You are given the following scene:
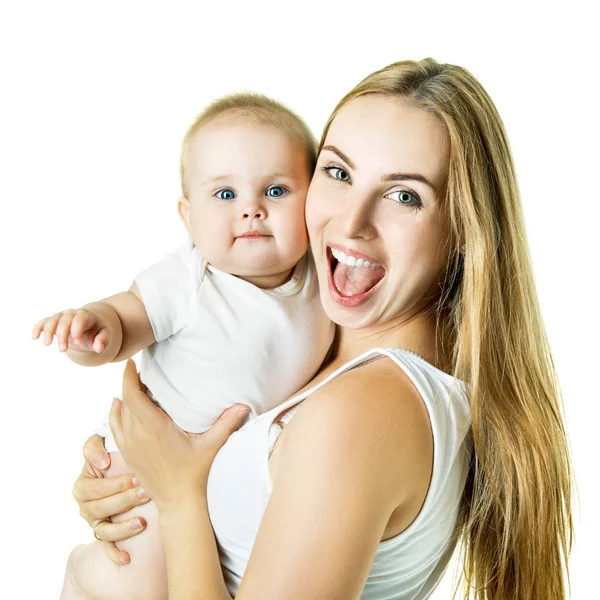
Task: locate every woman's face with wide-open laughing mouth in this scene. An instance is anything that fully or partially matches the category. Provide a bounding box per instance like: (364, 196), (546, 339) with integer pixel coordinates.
(306, 94), (449, 329)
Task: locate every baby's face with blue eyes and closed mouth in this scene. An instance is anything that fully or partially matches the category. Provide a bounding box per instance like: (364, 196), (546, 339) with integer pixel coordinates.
(180, 117), (312, 287)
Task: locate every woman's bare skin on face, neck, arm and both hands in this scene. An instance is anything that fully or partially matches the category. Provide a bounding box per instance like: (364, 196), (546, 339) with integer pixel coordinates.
(74, 96), (449, 600)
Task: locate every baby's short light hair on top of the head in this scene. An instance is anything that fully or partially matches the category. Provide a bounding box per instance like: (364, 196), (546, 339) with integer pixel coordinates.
(179, 92), (318, 197)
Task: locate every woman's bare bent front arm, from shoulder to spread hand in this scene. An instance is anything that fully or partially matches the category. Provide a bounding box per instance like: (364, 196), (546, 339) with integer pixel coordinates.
(111, 359), (433, 600)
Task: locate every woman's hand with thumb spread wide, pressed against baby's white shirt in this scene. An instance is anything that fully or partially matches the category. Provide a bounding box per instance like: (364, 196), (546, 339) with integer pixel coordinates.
(110, 360), (250, 510)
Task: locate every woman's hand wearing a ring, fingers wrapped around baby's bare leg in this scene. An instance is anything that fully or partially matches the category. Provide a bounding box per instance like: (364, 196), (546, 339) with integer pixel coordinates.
(73, 435), (149, 565)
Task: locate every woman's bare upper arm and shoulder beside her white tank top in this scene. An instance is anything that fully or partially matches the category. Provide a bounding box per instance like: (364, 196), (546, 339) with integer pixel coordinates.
(236, 359), (433, 600)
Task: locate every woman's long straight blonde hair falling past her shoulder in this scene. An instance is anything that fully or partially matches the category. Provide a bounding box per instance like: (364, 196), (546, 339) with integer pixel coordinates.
(319, 58), (573, 600)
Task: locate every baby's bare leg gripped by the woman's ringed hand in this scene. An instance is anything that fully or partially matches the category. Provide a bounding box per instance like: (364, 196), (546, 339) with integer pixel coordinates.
(61, 452), (167, 600)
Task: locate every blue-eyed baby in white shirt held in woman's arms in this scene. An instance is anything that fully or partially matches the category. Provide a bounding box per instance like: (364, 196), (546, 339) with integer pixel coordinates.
(33, 94), (334, 600)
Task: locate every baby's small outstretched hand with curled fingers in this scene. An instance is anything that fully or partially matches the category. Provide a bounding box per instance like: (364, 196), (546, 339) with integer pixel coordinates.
(32, 308), (109, 354)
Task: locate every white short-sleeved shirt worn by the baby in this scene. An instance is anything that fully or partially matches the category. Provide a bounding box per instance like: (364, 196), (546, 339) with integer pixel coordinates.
(96, 241), (335, 452)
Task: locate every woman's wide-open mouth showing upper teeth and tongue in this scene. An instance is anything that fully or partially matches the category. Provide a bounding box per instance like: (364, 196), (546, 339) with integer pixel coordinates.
(326, 246), (386, 308)
